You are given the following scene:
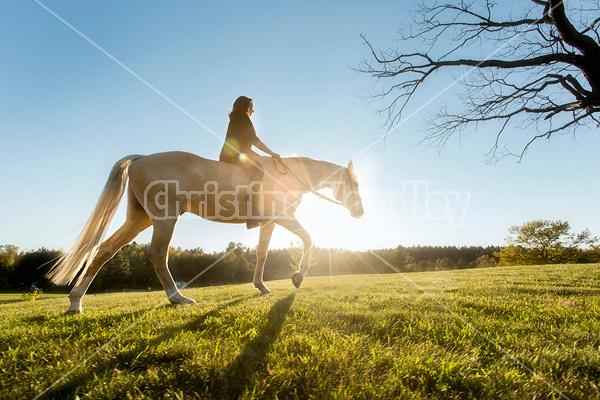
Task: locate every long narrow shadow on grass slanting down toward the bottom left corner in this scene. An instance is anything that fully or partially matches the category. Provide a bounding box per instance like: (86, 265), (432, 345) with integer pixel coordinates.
(43, 296), (255, 399)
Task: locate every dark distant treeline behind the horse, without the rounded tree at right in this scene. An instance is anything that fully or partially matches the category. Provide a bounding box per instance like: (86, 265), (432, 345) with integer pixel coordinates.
(0, 242), (501, 291)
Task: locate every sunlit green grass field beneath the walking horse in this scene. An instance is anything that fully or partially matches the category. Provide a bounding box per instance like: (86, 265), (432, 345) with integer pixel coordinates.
(0, 264), (600, 399)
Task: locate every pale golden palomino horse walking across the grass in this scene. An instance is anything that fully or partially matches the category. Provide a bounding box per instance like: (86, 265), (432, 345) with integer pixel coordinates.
(48, 152), (363, 314)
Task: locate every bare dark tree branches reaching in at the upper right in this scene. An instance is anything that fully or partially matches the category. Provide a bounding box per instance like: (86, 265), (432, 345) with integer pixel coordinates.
(357, 0), (600, 161)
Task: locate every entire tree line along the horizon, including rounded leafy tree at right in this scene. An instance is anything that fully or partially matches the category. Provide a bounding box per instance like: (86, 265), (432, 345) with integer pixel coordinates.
(0, 220), (600, 292)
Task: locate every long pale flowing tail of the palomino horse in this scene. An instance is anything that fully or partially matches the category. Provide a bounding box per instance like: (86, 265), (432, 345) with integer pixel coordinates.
(47, 155), (143, 285)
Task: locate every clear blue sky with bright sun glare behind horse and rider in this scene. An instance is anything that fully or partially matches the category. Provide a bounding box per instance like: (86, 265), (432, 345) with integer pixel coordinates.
(0, 0), (600, 251)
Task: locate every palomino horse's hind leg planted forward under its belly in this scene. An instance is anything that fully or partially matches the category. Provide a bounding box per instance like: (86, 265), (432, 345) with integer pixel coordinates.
(148, 218), (196, 304)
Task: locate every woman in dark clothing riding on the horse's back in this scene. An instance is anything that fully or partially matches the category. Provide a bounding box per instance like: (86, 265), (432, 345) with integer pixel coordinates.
(219, 96), (281, 229)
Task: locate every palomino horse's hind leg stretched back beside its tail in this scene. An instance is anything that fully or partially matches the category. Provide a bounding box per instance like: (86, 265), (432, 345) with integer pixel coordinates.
(65, 198), (152, 314)
